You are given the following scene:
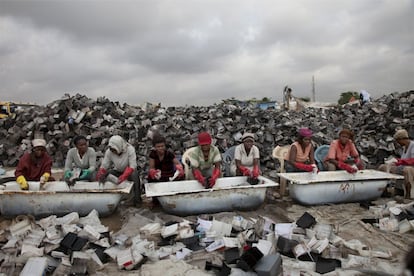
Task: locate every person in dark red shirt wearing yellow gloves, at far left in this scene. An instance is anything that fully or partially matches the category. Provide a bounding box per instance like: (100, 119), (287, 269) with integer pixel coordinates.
(14, 139), (54, 190)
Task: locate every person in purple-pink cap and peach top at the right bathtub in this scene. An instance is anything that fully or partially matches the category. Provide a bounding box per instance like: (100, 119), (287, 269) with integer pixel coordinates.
(286, 128), (317, 172)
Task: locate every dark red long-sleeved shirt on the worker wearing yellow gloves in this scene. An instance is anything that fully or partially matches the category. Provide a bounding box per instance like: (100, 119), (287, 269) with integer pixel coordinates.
(14, 152), (52, 181)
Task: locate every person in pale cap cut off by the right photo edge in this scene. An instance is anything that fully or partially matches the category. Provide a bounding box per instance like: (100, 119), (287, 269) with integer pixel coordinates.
(378, 129), (414, 198)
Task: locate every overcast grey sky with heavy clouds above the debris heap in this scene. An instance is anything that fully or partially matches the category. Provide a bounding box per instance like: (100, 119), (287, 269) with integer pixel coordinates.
(0, 0), (414, 106)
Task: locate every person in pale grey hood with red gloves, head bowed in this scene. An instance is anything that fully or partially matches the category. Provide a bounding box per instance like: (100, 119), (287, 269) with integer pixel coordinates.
(96, 135), (141, 204)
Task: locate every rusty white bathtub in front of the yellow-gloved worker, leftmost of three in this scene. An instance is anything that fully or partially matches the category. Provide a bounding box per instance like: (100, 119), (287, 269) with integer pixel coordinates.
(0, 181), (133, 217)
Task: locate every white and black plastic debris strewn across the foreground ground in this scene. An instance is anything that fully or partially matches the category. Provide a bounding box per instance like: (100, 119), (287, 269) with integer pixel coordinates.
(0, 198), (414, 276)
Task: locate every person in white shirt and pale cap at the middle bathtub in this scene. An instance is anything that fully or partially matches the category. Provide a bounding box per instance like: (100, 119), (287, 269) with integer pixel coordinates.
(234, 132), (260, 179)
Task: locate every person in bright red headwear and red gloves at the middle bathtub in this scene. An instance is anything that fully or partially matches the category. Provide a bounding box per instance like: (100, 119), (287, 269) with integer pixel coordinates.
(184, 132), (221, 188)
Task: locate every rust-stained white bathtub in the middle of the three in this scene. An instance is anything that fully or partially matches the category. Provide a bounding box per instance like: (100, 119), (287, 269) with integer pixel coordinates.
(145, 176), (279, 216)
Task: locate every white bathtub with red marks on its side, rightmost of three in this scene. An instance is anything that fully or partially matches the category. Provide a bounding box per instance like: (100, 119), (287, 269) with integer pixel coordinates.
(278, 170), (404, 205)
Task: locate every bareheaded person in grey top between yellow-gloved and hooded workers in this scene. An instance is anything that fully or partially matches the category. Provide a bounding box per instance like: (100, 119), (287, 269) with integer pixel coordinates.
(64, 135), (96, 182)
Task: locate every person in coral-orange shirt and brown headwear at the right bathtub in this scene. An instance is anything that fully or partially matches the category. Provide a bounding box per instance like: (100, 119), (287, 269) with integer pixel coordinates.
(324, 128), (364, 173)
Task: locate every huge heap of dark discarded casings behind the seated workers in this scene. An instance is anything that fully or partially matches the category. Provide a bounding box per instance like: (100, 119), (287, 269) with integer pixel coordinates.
(0, 91), (414, 178)
